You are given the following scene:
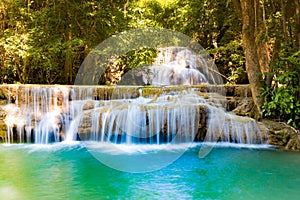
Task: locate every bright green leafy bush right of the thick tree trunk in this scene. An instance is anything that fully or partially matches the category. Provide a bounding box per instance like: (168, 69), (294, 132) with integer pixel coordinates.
(261, 48), (300, 129)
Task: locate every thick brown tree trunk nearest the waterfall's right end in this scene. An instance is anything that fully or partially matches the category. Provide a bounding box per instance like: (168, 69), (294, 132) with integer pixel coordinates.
(240, 0), (264, 119)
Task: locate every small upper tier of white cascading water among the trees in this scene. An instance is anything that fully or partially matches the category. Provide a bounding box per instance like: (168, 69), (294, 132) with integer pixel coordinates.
(137, 47), (219, 85)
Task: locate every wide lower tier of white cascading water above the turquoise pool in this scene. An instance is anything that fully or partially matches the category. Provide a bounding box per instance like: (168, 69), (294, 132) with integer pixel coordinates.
(0, 86), (264, 144)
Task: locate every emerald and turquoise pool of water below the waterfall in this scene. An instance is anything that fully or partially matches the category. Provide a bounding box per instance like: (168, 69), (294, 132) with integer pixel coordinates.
(0, 144), (300, 199)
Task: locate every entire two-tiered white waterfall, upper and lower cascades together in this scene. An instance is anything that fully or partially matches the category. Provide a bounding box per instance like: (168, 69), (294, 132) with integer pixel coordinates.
(0, 47), (265, 144)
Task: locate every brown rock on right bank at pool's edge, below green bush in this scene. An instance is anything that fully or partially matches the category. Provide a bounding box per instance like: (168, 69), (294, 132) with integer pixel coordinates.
(259, 119), (300, 151)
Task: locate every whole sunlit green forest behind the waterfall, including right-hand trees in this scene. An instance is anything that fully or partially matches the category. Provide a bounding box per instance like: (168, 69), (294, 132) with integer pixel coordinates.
(0, 0), (300, 128)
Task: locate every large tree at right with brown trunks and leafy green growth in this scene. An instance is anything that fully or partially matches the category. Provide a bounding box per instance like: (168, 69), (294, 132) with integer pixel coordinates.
(232, 0), (300, 128)
